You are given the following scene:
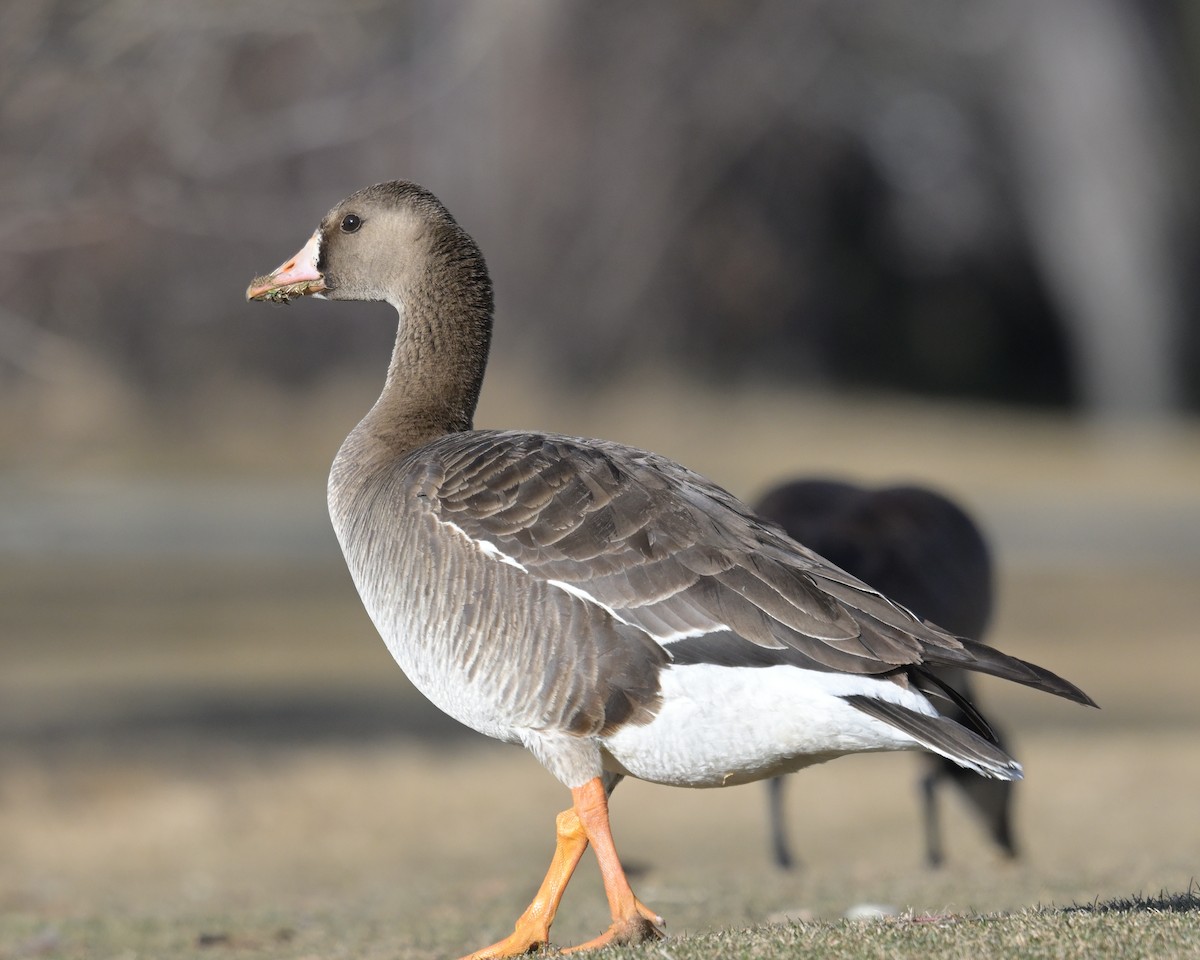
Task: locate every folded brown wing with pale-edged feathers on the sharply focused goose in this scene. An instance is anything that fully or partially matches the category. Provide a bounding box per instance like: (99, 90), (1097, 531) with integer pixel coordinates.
(416, 431), (970, 673)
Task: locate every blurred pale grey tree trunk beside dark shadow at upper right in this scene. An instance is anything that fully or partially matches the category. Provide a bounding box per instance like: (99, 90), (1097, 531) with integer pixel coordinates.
(1002, 0), (1186, 416)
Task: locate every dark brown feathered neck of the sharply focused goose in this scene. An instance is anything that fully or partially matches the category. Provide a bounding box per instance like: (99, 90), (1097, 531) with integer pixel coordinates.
(359, 221), (493, 455)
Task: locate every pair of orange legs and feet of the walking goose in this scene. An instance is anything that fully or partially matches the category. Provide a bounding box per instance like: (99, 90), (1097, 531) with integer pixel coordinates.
(462, 778), (662, 960)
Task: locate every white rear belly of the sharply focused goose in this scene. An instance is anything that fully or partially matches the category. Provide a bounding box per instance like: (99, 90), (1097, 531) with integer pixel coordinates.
(604, 664), (935, 787)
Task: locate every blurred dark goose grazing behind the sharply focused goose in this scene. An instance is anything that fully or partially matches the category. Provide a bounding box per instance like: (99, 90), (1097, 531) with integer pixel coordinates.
(755, 478), (1016, 868)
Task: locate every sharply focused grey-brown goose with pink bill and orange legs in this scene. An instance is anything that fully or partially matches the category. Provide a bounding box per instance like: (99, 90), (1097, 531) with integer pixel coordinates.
(246, 181), (1091, 956)
